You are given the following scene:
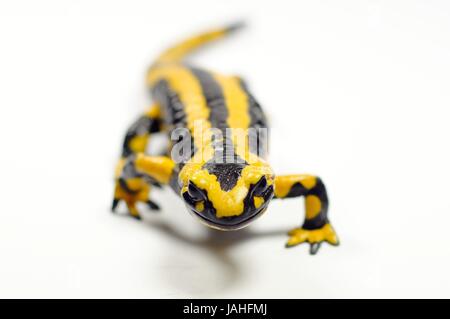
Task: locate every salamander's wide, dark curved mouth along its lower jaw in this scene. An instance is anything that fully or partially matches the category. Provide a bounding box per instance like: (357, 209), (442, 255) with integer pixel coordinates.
(188, 203), (268, 231)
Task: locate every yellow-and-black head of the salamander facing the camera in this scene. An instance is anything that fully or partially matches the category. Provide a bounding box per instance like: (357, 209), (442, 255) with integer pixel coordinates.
(180, 162), (274, 230)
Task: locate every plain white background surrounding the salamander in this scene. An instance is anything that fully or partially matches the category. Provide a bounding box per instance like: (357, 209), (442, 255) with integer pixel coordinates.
(0, 0), (450, 298)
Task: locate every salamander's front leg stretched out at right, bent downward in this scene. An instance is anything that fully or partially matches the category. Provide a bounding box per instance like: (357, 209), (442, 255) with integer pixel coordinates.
(275, 175), (339, 255)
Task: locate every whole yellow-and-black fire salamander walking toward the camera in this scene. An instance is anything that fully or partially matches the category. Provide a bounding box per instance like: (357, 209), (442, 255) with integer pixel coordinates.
(112, 25), (338, 254)
